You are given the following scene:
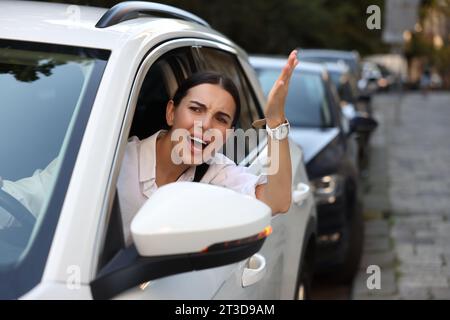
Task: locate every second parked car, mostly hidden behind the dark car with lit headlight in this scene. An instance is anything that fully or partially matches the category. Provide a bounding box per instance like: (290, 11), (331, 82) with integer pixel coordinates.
(325, 63), (378, 175)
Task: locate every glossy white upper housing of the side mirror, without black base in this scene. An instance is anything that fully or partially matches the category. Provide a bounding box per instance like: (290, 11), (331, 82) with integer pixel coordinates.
(131, 182), (272, 257)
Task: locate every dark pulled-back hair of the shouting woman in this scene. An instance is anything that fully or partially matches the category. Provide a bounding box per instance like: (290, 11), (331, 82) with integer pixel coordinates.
(172, 71), (241, 127)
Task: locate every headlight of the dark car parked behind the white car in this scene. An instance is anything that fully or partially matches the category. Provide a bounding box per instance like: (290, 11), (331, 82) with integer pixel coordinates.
(310, 174), (344, 204)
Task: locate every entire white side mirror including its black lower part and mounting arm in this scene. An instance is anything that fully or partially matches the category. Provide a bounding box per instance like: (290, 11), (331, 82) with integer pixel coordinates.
(91, 182), (272, 299)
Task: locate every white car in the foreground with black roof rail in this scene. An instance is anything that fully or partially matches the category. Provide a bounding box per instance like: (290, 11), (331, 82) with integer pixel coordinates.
(0, 1), (316, 299)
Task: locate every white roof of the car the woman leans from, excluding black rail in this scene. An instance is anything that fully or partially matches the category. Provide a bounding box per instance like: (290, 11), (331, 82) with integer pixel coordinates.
(0, 0), (243, 53)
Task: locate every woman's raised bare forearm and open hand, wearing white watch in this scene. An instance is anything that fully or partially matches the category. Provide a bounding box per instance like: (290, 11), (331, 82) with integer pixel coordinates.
(255, 50), (298, 214)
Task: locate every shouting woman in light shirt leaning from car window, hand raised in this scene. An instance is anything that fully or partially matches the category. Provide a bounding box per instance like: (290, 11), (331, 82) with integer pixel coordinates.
(0, 50), (298, 242)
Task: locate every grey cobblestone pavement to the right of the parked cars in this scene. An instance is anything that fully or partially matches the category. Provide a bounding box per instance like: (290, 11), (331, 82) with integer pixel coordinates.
(351, 93), (450, 299)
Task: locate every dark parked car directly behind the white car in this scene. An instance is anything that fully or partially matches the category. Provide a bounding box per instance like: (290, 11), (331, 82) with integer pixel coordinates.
(250, 56), (372, 282)
